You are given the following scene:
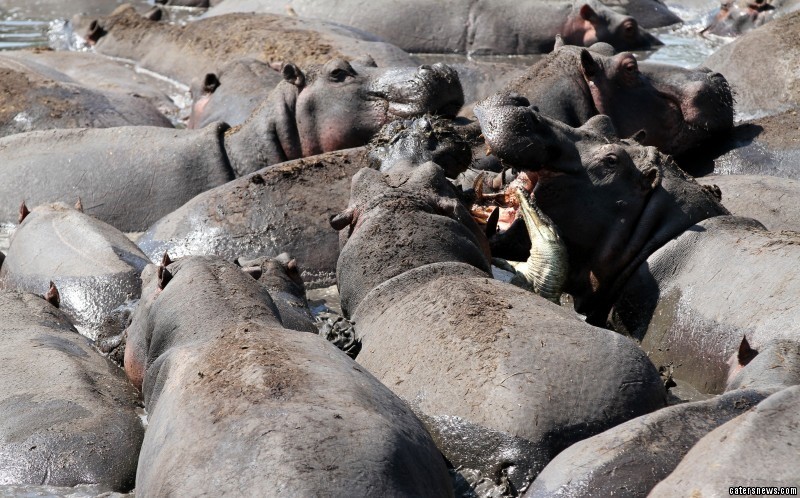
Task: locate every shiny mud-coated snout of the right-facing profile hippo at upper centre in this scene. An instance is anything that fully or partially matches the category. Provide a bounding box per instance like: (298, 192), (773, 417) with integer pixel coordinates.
(367, 63), (464, 118)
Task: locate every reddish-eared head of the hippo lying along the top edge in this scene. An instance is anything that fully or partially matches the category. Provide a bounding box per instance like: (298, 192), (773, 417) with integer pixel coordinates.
(561, 3), (662, 50)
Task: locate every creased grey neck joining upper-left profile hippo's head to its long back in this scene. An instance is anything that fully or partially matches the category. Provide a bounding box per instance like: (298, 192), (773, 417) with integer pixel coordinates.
(225, 82), (302, 177)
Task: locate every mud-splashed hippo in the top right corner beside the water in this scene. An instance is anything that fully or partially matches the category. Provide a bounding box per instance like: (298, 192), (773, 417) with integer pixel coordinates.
(703, 0), (800, 36)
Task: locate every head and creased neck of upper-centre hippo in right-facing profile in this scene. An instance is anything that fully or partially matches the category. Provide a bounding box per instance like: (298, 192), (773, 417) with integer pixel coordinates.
(226, 59), (464, 171)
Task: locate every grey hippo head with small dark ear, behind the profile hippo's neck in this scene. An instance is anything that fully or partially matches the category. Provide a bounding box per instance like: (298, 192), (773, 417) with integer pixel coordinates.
(187, 59), (283, 128)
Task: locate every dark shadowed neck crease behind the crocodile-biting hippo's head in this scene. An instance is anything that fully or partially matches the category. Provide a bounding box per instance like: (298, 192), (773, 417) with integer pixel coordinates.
(576, 160), (730, 326)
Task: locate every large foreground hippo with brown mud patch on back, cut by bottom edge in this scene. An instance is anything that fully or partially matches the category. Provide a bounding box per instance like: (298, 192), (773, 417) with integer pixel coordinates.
(125, 257), (453, 496)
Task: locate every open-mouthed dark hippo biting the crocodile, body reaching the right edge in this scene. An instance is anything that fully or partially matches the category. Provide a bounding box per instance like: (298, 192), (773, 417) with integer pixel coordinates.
(476, 95), (800, 394)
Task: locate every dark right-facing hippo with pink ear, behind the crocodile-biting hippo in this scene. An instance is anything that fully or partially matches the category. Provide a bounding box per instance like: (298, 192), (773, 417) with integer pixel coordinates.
(505, 44), (733, 155)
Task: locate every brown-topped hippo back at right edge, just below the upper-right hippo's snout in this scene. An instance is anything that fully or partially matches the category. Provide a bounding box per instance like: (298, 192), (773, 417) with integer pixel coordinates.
(681, 110), (800, 180)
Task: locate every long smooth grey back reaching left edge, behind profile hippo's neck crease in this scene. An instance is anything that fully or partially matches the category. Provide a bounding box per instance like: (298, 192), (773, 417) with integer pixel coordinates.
(0, 124), (234, 232)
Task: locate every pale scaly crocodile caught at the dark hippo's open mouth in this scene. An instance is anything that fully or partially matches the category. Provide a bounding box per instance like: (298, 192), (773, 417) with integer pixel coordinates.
(500, 189), (569, 304)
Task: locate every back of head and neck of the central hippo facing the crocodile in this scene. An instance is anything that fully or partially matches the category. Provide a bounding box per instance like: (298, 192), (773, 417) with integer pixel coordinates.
(331, 162), (490, 314)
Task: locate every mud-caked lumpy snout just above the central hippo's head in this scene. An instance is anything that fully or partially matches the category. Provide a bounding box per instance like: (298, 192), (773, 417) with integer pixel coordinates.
(367, 115), (472, 178)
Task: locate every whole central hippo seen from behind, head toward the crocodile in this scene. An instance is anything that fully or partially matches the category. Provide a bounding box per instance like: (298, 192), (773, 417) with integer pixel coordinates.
(331, 163), (664, 492)
